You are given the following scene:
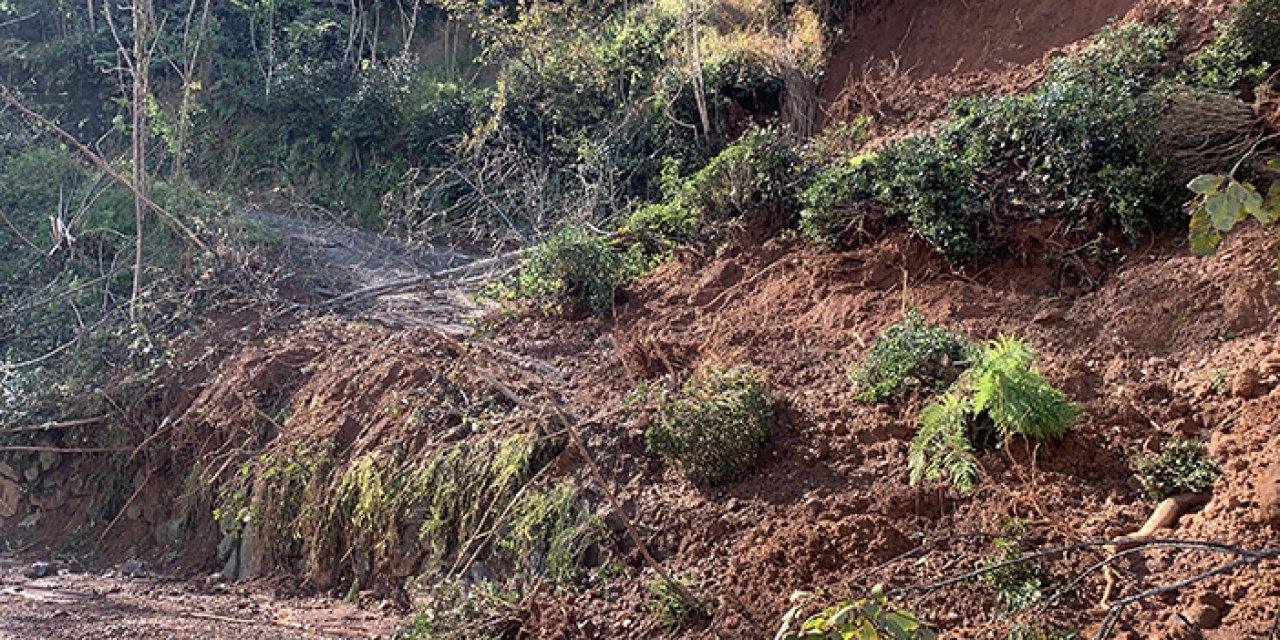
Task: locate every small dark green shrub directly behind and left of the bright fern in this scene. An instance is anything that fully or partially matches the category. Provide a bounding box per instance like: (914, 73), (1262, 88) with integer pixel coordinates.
(850, 308), (973, 402)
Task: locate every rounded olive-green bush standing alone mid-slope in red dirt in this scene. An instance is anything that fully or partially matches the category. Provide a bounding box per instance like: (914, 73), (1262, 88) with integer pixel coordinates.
(644, 366), (773, 485)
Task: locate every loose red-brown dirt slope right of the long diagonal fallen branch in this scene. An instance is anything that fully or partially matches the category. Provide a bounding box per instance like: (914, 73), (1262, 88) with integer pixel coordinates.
(488, 224), (1280, 639)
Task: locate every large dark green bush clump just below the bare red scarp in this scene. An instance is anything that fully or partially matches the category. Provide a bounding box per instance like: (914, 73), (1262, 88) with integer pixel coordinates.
(876, 23), (1175, 262)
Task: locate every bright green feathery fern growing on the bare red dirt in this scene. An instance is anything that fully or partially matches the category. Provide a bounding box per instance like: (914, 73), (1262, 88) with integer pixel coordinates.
(908, 337), (1079, 493)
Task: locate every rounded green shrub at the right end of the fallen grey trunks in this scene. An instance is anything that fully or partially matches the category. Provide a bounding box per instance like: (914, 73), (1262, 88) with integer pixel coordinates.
(509, 227), (637, 317)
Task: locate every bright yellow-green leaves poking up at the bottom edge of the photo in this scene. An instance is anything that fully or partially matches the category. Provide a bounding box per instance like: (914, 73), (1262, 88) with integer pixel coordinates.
(774, 586), (934, 640)
